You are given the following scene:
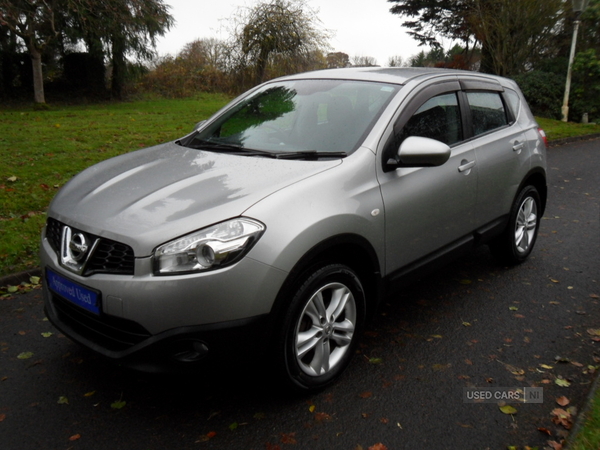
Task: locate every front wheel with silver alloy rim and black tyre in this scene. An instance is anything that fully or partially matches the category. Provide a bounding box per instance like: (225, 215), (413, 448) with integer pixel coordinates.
(277, 264), (365, 391)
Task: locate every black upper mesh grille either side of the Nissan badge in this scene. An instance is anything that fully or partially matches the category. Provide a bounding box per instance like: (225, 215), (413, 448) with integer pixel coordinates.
(46, 218), (135, 276)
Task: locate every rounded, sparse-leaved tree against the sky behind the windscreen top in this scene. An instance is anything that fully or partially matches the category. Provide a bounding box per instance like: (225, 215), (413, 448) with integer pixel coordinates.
(233, 0), (329, 83)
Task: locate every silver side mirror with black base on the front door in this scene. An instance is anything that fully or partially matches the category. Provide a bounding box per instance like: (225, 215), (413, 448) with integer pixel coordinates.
(387, 136), (451, 168)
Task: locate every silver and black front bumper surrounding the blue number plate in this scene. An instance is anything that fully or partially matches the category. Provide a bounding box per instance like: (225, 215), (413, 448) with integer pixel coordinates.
(41, 234), (285, 372)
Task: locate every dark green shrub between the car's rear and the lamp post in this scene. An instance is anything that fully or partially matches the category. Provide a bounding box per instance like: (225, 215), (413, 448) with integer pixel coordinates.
(514, 70), (566, 119)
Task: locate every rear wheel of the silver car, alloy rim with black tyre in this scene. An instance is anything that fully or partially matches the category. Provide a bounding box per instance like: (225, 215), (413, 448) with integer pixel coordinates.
(490, 186), (542, 264)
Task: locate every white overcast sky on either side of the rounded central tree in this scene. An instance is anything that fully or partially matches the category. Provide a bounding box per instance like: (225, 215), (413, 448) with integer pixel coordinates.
(157, 0), (423, 66)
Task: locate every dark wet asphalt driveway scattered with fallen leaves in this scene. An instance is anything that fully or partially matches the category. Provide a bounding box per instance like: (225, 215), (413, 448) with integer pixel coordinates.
(0, 140), (600, 450)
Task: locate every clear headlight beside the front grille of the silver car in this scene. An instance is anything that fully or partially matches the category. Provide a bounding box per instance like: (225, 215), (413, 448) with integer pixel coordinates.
(154, 218), (265, 275)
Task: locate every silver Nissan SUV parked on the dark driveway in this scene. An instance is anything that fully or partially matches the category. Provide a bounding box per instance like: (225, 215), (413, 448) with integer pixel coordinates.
(41, 68), (547, 390)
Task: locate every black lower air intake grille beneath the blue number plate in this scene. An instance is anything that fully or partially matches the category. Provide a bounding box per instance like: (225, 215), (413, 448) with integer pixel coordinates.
(52, 293), (151, 351)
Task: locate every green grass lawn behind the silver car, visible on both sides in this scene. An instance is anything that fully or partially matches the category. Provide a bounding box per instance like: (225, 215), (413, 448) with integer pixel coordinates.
(0, 99), (600, 276)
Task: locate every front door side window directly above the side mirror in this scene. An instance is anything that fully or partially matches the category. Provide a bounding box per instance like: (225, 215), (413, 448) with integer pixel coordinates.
(400, 93), (462, 145)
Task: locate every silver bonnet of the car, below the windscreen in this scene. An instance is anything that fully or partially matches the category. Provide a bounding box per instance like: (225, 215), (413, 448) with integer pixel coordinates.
(48, 143), (341, 257)
